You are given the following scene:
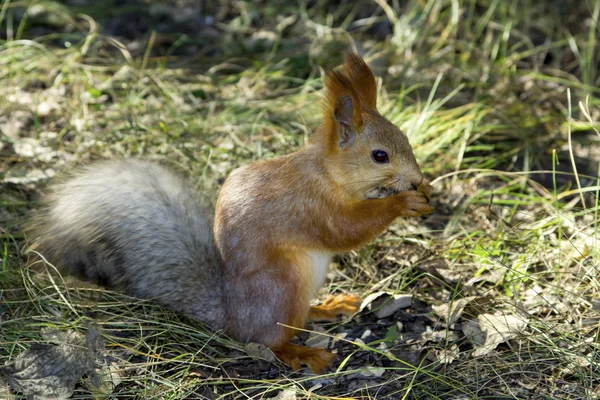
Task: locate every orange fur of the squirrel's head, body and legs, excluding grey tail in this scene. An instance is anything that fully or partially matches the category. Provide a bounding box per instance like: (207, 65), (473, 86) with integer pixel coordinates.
(214, 54), (432, 371)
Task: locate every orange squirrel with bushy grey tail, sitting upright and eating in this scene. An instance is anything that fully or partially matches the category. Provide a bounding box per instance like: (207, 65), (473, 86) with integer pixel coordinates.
(31, 53), (433, 372)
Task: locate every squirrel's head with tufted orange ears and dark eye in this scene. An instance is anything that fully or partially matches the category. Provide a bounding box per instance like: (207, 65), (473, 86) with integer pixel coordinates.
(319, 53), (423, 199)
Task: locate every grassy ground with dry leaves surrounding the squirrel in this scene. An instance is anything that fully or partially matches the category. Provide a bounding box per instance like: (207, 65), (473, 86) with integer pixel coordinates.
(0, 0), (600, 399)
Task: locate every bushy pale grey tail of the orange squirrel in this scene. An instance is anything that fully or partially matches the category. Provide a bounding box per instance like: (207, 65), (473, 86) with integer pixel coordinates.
(33, 160), (224, 328)
